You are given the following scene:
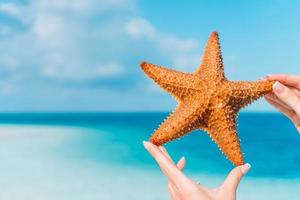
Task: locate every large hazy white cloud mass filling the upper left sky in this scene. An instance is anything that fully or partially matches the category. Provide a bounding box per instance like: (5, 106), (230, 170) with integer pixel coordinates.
(0, 0), (197, 84)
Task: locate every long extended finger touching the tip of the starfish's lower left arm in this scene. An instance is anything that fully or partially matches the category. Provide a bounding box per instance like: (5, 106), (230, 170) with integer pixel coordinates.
(143, 141), (187, 185)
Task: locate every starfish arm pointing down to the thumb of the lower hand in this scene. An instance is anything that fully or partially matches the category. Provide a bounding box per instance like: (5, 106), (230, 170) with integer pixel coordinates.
(206, 108), (244, 165)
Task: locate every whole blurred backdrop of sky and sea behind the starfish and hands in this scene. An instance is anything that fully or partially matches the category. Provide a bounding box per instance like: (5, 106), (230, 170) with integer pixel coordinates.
(0, 0), (300, 200)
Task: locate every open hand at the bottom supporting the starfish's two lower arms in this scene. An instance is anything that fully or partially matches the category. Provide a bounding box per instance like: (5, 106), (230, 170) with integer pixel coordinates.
(143, 142), (250, 200)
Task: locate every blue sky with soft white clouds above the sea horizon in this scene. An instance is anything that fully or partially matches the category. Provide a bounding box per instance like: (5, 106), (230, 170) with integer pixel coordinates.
(0, 0), (300, 112)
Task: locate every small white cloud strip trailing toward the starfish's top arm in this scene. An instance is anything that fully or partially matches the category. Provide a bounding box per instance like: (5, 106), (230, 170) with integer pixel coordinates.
(125, 18), (200, 71)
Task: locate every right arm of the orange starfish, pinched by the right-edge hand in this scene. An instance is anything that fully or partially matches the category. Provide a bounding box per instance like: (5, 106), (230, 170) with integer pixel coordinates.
(229, 81), (274, 111)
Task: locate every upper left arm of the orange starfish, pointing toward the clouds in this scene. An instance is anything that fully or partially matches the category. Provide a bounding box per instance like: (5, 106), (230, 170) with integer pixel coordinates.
(141, 62), (196, 101)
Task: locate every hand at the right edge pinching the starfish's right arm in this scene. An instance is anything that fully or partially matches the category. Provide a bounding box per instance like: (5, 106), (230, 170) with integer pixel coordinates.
(265, 74), (300, 133)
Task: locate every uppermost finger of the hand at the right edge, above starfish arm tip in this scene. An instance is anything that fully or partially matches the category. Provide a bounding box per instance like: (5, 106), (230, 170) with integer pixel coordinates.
(267, 74), (300, 89)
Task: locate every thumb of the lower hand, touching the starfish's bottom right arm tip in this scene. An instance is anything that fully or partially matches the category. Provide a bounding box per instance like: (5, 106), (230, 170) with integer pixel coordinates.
(223, 163), (251, 191)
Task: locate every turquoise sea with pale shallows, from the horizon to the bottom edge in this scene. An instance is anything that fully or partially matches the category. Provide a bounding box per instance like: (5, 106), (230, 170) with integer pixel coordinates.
(0, 113), (300, 200)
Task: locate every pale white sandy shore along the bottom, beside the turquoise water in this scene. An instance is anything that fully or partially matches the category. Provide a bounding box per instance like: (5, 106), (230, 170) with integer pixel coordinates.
(0, 126), (300, 200)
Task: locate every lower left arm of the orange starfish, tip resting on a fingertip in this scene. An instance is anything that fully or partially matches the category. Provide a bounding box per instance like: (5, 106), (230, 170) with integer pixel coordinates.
(150, 103), (206, 145)
